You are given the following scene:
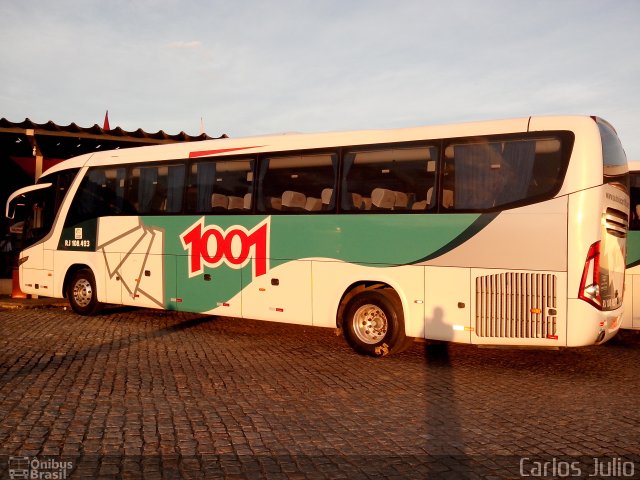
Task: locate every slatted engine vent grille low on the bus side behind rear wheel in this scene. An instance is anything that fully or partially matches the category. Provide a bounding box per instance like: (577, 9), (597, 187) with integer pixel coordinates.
(475, 272), (558, 339)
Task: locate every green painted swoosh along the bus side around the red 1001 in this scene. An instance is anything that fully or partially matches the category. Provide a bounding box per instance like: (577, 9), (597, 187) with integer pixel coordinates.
(142, 213), (497, 311)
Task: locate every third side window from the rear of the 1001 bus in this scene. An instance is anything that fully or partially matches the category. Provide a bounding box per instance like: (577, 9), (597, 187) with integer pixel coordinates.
(256, 153), (338, 213)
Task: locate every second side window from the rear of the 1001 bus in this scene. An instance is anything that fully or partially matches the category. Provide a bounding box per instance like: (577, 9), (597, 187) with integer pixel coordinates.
(340, 147), (438, 212)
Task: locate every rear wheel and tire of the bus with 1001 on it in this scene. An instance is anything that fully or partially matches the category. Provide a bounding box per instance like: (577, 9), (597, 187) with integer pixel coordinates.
(342, 290), (407, 357)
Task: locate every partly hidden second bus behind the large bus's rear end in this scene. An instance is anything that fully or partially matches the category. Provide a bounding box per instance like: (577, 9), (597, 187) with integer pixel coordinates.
(621, 160), (640, 330)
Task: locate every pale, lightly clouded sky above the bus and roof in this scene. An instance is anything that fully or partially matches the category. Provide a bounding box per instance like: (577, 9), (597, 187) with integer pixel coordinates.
(0, 0), (640, 160)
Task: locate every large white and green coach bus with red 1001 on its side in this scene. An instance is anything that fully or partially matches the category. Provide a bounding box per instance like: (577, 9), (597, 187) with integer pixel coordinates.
(6, 116), (629, 356)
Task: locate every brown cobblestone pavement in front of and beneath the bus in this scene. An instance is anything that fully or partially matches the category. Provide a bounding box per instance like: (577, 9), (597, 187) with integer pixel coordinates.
(0, 308), (640, 479)
